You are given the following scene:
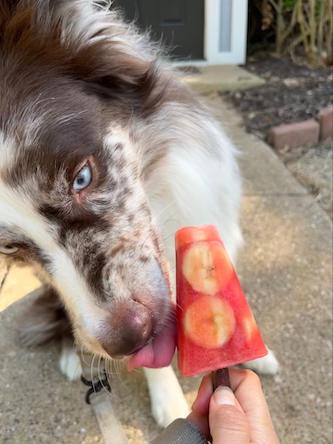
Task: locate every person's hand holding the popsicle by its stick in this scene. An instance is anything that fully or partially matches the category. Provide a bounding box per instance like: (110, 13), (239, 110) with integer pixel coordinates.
(188, 369), (279, 444)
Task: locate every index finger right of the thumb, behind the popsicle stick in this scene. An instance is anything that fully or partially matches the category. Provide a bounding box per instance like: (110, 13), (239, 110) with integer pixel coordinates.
(230, 369), (279, 444)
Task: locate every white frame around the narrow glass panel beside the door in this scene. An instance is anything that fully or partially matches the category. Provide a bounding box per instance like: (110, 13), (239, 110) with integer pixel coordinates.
(204, 0), (248, 65)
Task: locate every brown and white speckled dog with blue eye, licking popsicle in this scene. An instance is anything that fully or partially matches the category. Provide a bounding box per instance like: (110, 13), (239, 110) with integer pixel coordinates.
(0, 0), (278, 425)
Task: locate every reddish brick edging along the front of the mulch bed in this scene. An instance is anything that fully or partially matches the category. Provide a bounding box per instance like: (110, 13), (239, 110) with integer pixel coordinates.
(269, 105), (333, 150)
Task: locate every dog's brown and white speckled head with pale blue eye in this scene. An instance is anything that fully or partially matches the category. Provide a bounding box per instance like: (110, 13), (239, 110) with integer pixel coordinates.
(0, 0), (171, 362)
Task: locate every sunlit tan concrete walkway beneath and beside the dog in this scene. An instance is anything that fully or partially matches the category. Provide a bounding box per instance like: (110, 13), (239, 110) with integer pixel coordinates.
(0, 97), (332, 444)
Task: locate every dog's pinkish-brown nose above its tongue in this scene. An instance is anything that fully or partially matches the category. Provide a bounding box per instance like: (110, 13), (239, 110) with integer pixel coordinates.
(101, 300), (154, 357)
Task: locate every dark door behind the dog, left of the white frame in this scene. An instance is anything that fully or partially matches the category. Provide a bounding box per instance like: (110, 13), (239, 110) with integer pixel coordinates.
(112, 0), (204, 59)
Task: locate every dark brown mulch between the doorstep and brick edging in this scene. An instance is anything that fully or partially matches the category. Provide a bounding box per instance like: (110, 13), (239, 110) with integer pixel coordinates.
(220, 54), (333, 140)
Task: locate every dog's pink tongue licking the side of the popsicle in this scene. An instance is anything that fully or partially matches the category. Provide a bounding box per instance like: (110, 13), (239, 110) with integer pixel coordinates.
(127, 320), (176, 370)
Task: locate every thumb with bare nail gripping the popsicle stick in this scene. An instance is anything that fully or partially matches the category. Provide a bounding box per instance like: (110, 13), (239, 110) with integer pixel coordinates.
(209, 386), (250, 444)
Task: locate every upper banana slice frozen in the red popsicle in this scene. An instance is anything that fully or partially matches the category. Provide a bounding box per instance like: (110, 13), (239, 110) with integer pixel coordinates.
(182, 242), (233, 296)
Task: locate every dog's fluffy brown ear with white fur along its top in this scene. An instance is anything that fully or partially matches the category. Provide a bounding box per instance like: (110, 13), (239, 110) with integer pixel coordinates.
(60, 9), (168, 111)
